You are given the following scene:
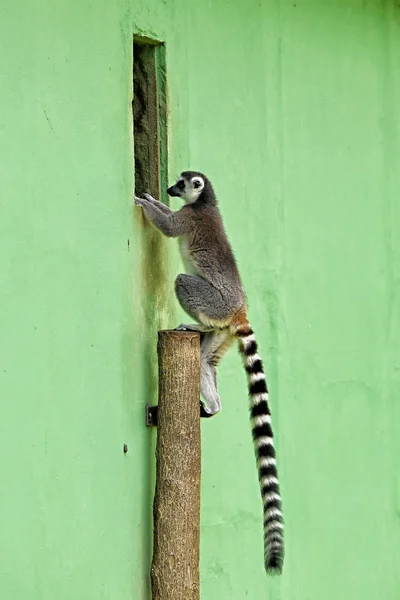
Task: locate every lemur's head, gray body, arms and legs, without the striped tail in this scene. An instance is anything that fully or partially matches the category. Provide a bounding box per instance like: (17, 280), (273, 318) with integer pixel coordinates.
(135, 171), (245, 414)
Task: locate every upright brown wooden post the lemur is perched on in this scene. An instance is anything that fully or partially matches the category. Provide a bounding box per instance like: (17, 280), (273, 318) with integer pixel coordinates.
(151, 330), (201, 600)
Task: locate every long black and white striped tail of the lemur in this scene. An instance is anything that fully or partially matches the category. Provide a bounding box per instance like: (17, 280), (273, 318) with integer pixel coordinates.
(236, 324), (284, 574)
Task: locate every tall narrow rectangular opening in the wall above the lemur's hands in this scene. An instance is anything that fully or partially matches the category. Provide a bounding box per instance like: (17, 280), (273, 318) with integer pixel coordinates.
(132, 37), (168, 202)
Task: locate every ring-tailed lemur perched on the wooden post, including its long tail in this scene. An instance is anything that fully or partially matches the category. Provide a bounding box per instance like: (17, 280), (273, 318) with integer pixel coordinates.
(135, 171), (284, 573)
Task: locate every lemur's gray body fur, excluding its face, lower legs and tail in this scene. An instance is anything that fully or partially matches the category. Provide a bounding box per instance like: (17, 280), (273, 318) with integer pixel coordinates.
(135, 171), (245, 323)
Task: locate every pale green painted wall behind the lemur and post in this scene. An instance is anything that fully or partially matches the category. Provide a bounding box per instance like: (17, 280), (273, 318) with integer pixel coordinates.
(0, 0), (400, 600)
